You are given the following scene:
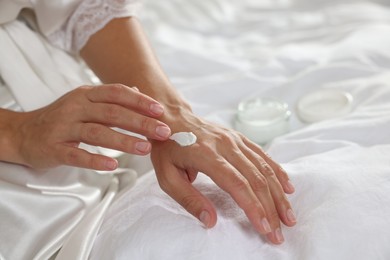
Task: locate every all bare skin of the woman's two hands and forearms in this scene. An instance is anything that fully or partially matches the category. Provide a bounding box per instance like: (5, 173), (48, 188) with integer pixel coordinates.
(0, 18), (296, 244)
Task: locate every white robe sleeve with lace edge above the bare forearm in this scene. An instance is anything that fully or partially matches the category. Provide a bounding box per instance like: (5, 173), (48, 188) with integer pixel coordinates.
(0, 0), (141, 53)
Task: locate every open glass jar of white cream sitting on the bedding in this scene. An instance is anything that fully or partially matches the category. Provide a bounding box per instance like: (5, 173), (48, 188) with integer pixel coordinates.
(235, 98), (291, 144)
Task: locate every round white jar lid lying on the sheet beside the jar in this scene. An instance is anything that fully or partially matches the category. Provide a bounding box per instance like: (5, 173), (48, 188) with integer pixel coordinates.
(297, 89), (353, 123)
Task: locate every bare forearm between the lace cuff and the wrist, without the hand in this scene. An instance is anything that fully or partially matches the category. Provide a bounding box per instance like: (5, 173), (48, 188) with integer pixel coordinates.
(81, 18), (190, 129)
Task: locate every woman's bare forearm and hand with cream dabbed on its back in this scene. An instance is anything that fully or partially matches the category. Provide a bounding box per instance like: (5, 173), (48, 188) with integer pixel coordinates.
(81, 18), (295, 244)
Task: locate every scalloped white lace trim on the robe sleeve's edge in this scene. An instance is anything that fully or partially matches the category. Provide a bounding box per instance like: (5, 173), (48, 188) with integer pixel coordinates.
(47, 0), (140, 53)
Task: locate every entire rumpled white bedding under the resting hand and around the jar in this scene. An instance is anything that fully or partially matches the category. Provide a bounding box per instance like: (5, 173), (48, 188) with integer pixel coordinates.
(91, 0), (390, 260)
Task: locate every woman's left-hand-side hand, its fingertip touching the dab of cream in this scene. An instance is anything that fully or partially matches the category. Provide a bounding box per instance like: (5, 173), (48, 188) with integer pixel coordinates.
(6, 84), (170, 170)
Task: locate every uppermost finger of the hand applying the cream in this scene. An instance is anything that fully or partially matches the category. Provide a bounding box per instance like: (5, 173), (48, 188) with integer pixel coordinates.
(86, 84), (164, 116)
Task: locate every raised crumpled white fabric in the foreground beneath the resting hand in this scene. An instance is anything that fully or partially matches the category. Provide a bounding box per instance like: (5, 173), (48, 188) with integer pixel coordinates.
(91, 144), (390, 260)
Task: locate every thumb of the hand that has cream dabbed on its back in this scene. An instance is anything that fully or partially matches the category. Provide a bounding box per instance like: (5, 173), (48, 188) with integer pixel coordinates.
(156, 162), (217, 228)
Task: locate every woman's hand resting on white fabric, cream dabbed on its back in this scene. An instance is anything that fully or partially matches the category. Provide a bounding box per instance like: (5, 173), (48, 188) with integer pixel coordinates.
(151, 107), (296, 244)
